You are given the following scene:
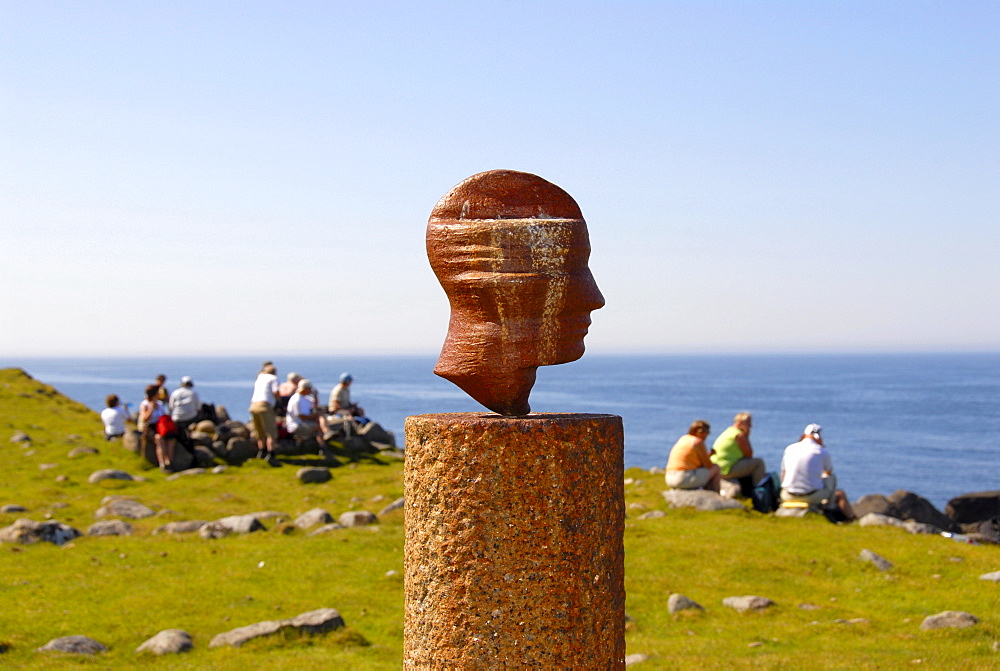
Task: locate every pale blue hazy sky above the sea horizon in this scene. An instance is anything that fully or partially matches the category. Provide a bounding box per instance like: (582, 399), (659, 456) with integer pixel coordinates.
(0, 0), (1000, 357)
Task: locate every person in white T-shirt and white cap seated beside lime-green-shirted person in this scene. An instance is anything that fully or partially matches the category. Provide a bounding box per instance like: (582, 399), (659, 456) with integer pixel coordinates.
(781, 424), (854, 520)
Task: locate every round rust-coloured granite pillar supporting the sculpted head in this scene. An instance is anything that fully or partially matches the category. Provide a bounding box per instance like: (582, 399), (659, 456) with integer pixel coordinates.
(403, 413), (625, 669)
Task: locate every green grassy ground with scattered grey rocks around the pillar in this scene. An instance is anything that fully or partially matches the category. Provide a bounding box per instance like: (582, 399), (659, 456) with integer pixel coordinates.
(0, 370), (1000, 670)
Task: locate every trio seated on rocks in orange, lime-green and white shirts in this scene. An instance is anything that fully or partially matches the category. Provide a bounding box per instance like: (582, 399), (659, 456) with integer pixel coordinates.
(666, 412), (854, 520)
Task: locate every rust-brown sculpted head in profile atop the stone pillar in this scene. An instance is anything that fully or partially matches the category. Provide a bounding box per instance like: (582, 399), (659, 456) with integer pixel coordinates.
(427, 170), (604, 416)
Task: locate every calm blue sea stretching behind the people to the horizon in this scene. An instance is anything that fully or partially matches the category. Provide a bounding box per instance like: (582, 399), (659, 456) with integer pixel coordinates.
(0, 353), (1000, 509)
